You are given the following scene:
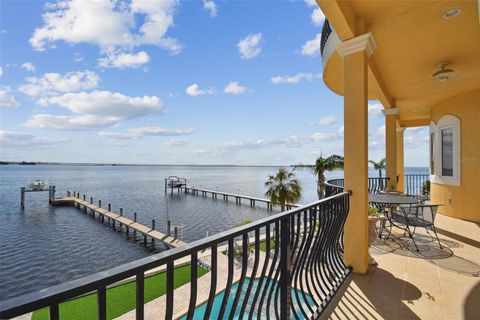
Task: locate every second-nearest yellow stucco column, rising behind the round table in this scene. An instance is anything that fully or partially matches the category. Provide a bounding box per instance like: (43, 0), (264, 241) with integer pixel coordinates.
(383, 109), (398, 190)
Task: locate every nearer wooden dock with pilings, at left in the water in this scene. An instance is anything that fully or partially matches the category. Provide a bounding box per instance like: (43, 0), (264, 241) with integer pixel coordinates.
(53, 195), (186, 248)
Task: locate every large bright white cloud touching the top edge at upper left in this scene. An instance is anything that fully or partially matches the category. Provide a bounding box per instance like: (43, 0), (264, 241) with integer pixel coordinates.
(30, 0), (182, 54)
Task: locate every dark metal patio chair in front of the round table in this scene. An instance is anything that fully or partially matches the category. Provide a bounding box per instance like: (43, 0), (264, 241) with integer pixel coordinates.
(391, 204), (443, 251)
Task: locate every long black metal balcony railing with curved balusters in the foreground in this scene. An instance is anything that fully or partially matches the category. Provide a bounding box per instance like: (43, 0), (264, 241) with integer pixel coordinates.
(0, 192), (350, 319)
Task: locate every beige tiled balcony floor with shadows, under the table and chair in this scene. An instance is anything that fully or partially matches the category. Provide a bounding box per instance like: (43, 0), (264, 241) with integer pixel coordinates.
(322, 215), (480, 320)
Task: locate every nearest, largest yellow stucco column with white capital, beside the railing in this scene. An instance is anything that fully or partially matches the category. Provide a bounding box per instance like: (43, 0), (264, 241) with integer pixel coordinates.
(337, 33), (375, 273)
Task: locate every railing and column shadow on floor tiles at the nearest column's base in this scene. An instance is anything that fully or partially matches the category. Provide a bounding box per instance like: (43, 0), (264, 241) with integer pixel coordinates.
(321, 268), (422, 320)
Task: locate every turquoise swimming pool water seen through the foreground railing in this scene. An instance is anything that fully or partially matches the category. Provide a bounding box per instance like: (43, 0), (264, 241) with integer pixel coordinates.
(180, 278), (314, 320)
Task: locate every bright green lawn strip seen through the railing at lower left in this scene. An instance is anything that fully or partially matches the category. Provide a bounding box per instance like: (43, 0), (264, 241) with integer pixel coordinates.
(32, 265), (207, 320)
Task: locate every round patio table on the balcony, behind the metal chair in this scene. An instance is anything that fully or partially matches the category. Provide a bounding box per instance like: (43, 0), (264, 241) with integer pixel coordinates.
(368, 193), (421, 238)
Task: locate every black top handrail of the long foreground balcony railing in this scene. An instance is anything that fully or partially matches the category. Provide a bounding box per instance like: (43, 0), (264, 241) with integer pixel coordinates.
(0, 192), (348, 319)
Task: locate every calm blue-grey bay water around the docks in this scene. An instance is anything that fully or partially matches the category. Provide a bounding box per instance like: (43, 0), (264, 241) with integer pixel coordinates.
(0, 165), (428, 300)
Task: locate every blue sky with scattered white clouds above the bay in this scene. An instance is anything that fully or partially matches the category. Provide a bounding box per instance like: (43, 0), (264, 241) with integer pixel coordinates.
(0, 0), (428, 166)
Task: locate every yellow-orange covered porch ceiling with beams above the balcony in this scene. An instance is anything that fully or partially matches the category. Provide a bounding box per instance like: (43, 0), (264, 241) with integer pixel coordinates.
(317, 0), (480, 127)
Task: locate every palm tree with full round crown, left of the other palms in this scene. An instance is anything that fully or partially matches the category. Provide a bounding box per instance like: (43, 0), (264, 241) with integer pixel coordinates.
(265, 168), (302, 211)
